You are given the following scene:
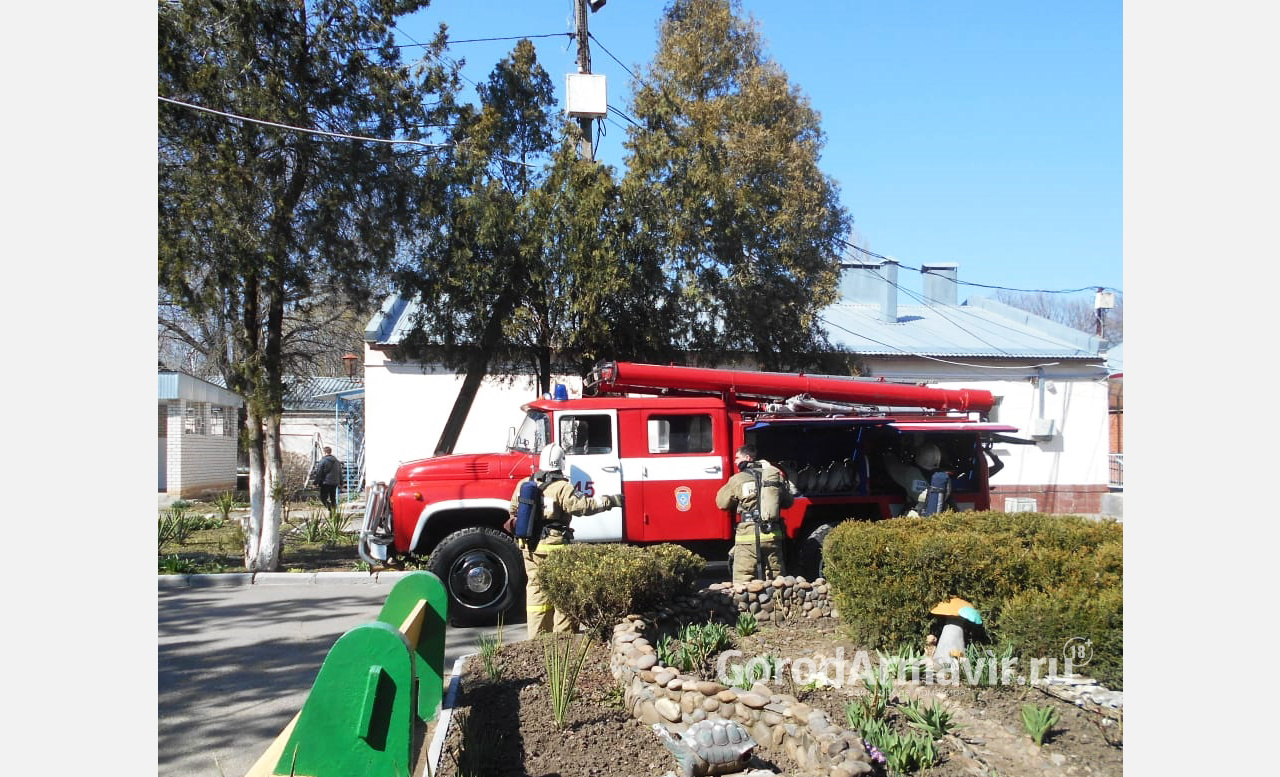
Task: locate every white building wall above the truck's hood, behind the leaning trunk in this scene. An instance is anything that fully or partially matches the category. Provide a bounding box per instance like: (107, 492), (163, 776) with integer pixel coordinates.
(365, 346), (582, 483)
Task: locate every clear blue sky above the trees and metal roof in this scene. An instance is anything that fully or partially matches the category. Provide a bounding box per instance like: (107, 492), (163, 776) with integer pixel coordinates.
(399, 0), (1124, 300)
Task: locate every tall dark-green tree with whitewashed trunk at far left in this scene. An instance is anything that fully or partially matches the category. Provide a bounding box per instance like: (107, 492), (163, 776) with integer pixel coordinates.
(156, 0), (460, 570)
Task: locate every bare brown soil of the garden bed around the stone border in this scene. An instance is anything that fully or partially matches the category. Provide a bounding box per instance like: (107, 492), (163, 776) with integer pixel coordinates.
(430, 622), (1124, 777)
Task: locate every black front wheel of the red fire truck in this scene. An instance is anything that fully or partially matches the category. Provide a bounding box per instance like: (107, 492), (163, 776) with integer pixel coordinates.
(426, 526), (525, 626)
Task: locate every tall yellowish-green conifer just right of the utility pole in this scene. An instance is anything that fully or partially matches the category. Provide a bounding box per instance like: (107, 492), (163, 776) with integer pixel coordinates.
(623, 0), (850, 370)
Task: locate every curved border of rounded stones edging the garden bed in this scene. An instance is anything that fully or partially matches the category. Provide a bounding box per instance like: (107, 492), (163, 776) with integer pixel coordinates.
(609, 577), (874, 777)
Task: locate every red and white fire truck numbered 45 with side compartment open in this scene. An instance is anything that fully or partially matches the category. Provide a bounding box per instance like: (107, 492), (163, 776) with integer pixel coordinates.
(360, 362), (1016, 623)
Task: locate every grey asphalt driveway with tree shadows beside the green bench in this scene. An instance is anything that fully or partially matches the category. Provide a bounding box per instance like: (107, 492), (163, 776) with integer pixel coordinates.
(157, 575), (504, 777)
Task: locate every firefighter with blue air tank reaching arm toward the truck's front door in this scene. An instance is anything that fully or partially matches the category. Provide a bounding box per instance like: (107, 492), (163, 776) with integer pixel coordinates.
(507, 443), (622, 639)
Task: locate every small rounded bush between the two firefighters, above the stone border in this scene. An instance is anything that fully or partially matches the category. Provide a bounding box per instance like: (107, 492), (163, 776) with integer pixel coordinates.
(538, 543), (705, 640)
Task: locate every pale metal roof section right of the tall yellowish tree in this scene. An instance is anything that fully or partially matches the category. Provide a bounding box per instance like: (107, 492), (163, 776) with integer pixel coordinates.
(820, 298), (1102, 360)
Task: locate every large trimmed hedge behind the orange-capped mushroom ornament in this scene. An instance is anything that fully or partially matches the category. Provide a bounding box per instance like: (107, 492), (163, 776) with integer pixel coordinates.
(823, 512), (1124, 689)
